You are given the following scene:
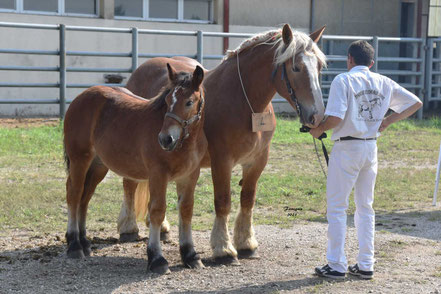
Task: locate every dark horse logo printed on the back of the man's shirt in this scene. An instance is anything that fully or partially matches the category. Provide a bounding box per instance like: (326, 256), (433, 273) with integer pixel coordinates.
(355, 90), (385, 122)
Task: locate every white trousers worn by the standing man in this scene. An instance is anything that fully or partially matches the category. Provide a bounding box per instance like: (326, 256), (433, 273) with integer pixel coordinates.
(326, 140), (378, 272)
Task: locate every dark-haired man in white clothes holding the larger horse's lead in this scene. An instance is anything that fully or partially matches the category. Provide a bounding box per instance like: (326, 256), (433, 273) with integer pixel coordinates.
(310, 41), (422, 279)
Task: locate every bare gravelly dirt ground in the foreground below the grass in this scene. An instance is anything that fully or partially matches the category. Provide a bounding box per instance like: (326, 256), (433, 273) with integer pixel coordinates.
(0, 207), (441, 293)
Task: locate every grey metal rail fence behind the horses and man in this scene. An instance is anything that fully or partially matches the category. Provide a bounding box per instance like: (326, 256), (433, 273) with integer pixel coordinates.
(0, 22), (441, 118)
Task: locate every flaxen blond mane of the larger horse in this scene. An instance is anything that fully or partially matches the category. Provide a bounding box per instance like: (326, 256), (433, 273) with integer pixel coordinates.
(223, 29), (326, 67)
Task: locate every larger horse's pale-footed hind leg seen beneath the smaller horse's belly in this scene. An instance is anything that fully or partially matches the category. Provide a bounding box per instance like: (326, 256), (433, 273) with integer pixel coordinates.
(118, 178), (139, 242)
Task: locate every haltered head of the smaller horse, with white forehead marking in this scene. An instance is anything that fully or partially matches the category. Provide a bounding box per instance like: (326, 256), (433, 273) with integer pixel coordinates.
(158, 63), (204, 151)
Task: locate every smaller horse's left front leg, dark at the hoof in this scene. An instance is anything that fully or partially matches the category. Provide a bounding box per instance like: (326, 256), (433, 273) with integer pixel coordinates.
(147, 177), (170, 274)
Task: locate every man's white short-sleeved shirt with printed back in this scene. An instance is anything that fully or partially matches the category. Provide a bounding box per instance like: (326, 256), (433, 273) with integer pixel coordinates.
(325, 66), (420, 141)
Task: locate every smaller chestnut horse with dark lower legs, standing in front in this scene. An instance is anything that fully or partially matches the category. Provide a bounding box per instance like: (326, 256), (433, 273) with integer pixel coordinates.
(64, 64), (207, 273)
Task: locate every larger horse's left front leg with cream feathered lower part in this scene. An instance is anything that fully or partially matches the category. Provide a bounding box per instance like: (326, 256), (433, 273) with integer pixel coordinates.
(210, 158), (239, 265)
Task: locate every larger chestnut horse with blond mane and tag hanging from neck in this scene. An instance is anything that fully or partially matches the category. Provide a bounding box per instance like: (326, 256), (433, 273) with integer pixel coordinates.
(119, 24), (326, 264)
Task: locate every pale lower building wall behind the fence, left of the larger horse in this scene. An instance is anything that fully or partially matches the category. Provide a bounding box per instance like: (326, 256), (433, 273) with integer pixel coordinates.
(0, 13), (270, 116)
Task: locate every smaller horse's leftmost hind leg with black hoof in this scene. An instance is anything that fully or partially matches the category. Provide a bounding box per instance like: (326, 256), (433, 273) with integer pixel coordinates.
(66, 153), (92, 258)
